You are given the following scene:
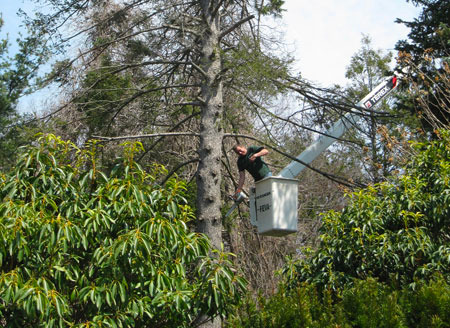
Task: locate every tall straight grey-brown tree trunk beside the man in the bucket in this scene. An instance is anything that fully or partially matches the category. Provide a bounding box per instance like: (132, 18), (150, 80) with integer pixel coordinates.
(197, 0), (223, 328)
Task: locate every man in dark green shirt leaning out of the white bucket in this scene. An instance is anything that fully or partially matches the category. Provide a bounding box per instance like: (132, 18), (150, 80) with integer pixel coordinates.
(233, 144), (272, 198)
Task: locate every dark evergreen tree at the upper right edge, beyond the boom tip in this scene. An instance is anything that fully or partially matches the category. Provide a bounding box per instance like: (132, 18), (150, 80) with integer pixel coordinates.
(395, 0), (450, 131)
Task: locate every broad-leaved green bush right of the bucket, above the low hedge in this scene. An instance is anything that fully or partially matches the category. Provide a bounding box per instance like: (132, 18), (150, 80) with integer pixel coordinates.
(285, 131), (450, 289)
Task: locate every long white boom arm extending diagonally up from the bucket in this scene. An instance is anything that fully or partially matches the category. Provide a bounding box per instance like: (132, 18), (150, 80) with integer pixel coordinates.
(279, 75), (398, 179)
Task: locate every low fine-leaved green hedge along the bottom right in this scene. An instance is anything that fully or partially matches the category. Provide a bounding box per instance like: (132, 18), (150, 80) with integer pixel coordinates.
(228, 278), (450, 328)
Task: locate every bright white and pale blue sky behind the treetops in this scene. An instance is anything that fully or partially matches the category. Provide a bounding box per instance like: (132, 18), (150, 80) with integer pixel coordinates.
(0, 0), (420, 111)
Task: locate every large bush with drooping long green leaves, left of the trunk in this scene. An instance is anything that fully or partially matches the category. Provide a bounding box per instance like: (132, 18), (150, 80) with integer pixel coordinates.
(0, 135), (245, 327)
